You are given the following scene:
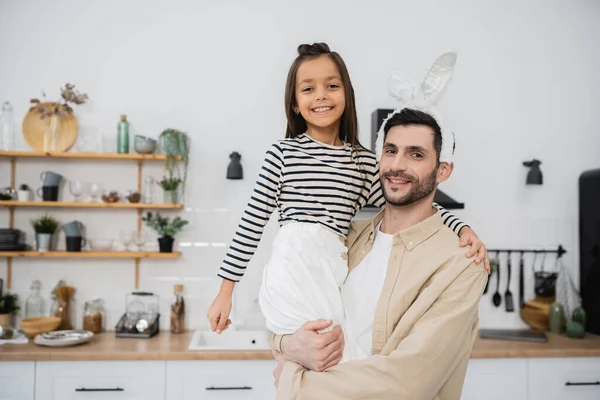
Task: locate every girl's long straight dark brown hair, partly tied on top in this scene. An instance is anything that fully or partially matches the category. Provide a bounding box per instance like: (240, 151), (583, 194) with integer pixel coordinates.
(285, 43), (363, 149)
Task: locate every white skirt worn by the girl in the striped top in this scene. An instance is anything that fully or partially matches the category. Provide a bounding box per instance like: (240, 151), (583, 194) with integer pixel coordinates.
(259, 222), (367, 362)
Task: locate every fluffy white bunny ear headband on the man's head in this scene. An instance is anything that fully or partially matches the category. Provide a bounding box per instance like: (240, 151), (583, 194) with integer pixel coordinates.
(375, 51), (456, 163)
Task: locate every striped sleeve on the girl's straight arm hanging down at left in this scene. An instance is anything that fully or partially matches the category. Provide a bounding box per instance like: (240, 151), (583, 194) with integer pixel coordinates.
(217, 143), (284, 282)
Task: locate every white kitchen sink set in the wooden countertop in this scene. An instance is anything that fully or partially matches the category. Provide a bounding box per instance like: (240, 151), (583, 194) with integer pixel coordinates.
(188, 329), (270, 350)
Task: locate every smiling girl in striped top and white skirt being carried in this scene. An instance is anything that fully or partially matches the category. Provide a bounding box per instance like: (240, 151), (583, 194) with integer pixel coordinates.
(207, 43), (485, 361)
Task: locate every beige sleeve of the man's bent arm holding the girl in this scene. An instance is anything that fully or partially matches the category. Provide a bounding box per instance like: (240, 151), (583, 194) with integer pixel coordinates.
(277, 263), (487, 400)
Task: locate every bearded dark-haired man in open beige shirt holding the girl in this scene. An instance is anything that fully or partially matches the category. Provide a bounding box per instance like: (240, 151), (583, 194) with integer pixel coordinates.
(271, 108), (487, 400)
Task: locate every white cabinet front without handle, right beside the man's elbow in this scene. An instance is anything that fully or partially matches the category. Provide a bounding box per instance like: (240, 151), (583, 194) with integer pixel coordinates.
(461, 358), (527, 400)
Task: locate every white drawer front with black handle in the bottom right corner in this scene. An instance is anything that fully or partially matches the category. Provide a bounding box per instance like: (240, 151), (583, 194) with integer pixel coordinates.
(528, 357), (600, 400)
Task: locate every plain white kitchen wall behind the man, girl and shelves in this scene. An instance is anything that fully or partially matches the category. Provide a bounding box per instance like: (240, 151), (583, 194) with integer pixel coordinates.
(0, 0), (600, 327)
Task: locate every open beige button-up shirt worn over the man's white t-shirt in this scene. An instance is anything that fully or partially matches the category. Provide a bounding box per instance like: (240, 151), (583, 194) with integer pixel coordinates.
(272, 211), (487, 400)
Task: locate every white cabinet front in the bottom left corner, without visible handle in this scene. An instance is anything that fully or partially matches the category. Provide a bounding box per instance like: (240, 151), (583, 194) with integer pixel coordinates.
(0, 361), (35, 400)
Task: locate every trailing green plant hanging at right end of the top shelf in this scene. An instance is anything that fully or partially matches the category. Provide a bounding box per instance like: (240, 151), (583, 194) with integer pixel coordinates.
(158, 128), (190, 200)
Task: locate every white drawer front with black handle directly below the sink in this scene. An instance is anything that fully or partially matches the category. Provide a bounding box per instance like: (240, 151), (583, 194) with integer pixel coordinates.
(166, 360), (276, 400)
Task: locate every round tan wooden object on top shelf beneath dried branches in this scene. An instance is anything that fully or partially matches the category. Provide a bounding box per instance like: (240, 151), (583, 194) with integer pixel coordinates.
(23, 102), (78, 152)
